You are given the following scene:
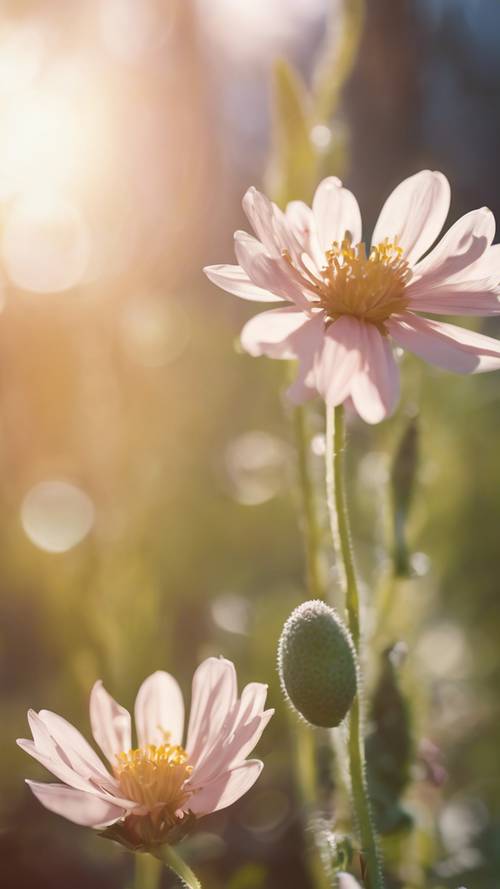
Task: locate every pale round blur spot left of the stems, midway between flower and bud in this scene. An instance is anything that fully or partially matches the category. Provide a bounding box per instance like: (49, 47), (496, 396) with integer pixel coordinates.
(226, 431), (289, 506)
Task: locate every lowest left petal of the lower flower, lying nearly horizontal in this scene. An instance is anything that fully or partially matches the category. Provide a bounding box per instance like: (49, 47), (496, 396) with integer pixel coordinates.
(26, 781), (124, 828)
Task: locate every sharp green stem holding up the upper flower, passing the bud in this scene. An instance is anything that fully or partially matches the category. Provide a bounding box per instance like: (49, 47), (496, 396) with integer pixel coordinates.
(326, 405), (384, 889)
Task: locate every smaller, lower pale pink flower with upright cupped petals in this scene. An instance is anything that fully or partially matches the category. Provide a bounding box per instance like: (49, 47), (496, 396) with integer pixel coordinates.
(18, 657), (274, 846)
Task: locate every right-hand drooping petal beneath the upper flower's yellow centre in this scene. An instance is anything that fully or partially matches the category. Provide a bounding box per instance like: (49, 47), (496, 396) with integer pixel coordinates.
(351, 323), (399, 423)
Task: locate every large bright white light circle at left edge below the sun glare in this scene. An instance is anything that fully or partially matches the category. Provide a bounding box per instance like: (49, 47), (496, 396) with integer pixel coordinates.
(2, 193), (89, 293)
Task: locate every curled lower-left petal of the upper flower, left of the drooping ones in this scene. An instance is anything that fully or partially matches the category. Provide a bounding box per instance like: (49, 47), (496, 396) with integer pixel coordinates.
(241, 307), (324, 358)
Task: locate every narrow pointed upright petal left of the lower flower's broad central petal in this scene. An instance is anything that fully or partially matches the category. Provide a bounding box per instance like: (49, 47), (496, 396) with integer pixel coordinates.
(90, 680), (132, 765)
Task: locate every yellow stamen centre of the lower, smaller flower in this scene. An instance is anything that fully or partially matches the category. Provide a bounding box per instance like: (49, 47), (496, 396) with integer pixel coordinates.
(115, 744), (193, 824)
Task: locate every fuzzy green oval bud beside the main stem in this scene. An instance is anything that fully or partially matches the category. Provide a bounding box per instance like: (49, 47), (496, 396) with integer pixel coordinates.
(278, 600), (357, 728)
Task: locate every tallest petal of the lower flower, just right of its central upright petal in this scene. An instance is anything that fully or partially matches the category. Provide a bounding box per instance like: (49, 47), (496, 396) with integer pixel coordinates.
(186, 657), (237, 765)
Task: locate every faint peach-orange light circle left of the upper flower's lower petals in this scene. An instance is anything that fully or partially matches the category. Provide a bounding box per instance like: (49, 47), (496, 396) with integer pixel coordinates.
(121, 293), (190, 367)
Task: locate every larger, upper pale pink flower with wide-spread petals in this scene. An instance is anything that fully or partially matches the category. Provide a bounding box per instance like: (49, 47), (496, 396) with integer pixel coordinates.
(205, 170), (500, 423)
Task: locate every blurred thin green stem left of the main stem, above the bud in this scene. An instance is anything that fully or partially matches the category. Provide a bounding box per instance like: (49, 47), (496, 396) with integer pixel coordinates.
(293, 407), (325, 599)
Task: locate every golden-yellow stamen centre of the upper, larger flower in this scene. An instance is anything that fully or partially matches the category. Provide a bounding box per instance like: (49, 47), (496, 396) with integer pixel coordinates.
(317, 237), (411, 328)
